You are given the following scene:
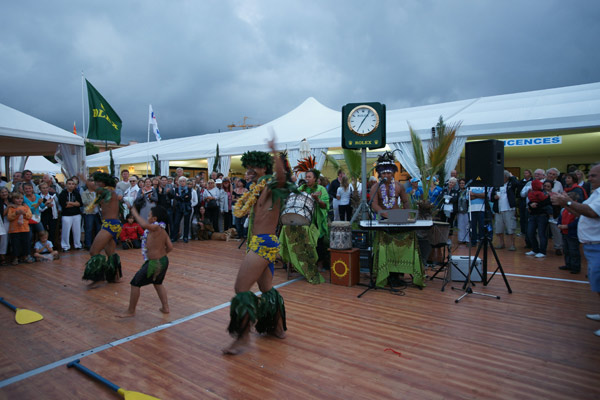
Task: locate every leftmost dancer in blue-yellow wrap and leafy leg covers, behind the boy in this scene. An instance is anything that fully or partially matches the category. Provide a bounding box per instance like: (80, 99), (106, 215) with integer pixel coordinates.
(82, 172), (123, 287)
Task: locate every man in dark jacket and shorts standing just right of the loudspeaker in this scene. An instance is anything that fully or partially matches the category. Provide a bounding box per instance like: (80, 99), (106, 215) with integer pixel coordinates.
(491, 170), (519, 251)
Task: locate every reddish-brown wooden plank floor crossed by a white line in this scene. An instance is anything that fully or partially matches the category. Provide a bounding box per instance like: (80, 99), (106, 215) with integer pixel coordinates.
(0, 234), (600, 400)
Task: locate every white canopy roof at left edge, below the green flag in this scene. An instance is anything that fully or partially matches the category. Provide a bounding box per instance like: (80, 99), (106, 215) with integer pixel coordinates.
(0, 104), (84, 156)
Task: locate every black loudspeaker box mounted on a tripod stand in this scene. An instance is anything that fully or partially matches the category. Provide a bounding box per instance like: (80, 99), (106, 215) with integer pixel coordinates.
(465, 139), (504, 187)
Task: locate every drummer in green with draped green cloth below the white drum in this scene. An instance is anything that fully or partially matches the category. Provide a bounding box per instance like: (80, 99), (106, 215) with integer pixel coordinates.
(279, 169), (329, 284)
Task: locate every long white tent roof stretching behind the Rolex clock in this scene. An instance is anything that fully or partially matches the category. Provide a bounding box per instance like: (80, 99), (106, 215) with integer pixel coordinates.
(87, 83), (600, 173)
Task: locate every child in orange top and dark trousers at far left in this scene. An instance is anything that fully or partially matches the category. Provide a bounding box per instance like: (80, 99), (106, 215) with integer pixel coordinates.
(7, 192), (35, 265)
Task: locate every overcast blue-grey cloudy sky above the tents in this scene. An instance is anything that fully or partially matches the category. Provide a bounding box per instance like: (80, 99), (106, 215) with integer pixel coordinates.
(0, 0), (600, 143)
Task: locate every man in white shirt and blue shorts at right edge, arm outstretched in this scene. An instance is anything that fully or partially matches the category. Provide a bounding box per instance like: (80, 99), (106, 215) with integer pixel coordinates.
(552, 163), (600, 336)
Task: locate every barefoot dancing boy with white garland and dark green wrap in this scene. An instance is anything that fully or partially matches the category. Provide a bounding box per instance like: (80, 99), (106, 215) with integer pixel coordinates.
(119, 206), (173, 318)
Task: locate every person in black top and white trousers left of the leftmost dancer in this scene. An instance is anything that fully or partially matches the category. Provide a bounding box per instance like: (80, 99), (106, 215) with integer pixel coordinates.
(58, 179), (83, 251)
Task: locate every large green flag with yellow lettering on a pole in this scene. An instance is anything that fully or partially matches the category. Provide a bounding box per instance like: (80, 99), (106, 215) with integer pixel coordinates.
(85, 79), (123, 144)
